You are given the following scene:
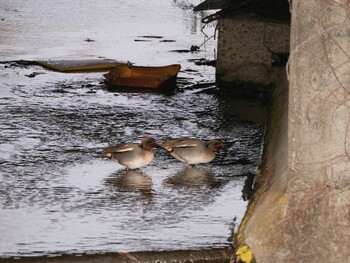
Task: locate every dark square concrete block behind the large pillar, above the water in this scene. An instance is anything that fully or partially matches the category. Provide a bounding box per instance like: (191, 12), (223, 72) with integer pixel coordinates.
(216, 17), (290, 85)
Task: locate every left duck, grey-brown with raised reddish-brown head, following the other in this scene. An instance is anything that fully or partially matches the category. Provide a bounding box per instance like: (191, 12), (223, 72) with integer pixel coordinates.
(103, 137), (157, 171)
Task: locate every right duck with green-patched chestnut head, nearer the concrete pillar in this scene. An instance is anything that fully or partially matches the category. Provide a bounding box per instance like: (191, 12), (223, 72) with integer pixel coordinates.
(160, 137), (224, 166)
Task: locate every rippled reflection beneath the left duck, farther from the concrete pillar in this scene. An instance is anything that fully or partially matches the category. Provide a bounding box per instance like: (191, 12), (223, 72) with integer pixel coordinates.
(106, 170), (153, 195)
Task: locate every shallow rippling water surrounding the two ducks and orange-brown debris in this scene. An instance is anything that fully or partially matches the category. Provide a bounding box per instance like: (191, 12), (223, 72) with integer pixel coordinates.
(0, 0), (264, 257)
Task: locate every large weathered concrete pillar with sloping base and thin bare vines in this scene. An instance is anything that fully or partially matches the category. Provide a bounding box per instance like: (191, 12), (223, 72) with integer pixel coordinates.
(237, 0), (350, 263)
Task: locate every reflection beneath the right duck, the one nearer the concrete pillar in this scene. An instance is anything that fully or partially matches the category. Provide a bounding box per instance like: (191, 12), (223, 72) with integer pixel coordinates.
(165, 166), (220, 188)
